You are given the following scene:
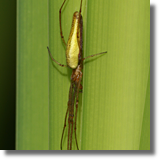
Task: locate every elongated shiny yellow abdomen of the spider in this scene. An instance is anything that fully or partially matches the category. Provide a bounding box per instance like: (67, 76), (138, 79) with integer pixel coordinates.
(66, 12), (80, 69)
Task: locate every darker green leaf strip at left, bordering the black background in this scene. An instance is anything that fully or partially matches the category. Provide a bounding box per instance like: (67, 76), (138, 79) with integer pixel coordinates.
(16, 0), (48, 150)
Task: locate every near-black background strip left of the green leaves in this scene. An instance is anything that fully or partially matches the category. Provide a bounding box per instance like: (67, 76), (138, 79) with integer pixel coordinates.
(0, 0), (16, 150)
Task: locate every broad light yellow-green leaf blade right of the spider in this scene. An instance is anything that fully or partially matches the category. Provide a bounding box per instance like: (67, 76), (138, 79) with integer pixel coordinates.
(82, 0), (150, 149)
